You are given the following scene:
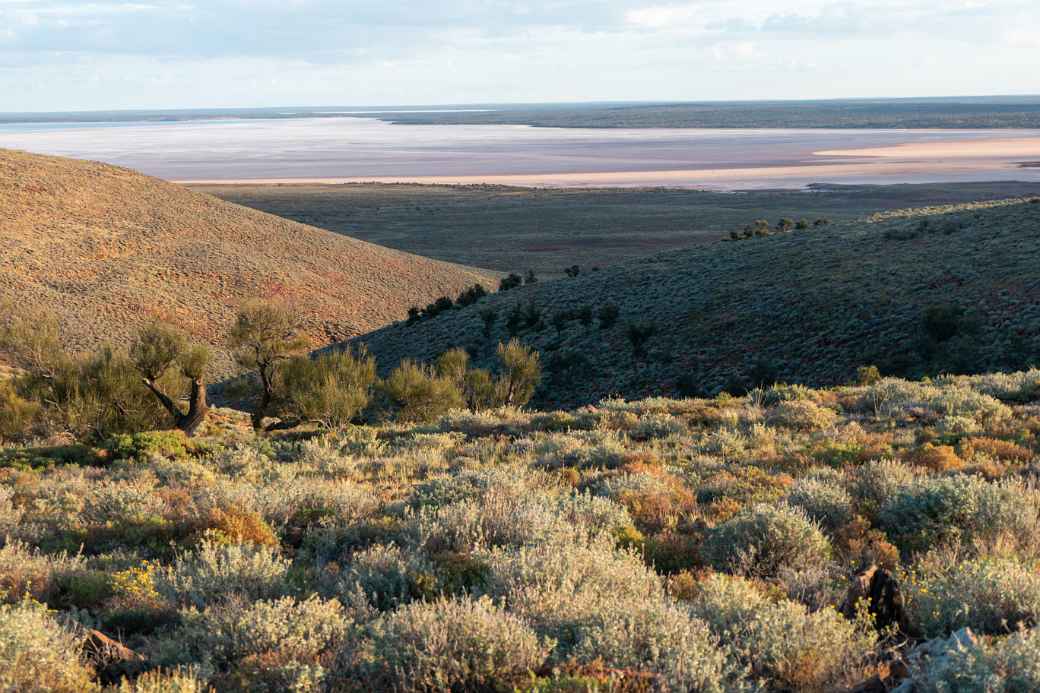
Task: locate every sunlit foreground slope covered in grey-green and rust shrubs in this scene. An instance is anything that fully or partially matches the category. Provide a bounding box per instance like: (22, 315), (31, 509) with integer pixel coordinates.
(0, 370), (1040, 693)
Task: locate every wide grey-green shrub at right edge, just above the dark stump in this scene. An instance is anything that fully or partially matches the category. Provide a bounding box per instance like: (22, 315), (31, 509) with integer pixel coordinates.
(878, 474), (1040, 550)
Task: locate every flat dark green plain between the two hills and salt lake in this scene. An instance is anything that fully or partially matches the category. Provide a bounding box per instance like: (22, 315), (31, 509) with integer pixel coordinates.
(191, 182), (1040, 278)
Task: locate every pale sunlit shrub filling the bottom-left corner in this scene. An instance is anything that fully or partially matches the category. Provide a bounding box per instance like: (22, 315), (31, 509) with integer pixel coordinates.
(0, 601), (99, 693)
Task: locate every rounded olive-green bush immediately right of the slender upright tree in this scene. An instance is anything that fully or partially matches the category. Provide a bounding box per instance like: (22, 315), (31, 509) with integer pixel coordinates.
(281, 351), (376, 429)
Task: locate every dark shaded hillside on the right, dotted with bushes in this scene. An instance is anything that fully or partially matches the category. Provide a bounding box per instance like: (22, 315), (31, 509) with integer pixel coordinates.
(349, 200), (1040, 405)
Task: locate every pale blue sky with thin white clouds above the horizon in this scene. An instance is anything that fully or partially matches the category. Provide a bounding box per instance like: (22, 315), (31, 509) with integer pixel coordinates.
(0, 0), (1040, 112)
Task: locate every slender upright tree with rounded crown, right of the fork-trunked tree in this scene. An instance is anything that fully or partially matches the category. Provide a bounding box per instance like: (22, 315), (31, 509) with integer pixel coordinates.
(230, 301), (307, 430)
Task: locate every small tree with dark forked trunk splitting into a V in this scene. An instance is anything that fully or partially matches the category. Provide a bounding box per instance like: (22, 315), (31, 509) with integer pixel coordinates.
(130, 323), (210, 436)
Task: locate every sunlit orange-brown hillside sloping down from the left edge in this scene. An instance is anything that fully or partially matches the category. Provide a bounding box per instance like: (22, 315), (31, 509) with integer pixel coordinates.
(0, 151), (490, 374)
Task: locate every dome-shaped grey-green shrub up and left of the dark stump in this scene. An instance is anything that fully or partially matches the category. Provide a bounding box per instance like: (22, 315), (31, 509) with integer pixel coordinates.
(701, 504), (831, 578)
